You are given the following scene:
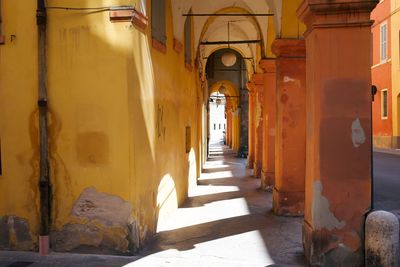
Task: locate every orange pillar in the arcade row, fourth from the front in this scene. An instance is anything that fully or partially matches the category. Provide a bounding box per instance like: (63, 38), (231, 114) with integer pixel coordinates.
(252, 73), (264, 178)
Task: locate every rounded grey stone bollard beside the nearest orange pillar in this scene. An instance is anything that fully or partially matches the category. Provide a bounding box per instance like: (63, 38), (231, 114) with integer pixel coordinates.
(365, 210), (399, 267)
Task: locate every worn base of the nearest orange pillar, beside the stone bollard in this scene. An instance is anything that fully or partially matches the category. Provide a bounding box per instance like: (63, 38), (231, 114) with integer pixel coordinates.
(303, 221), (364, 267)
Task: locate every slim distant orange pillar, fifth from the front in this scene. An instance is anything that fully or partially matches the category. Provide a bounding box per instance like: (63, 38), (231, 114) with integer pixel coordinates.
(247, 82), (255, 169)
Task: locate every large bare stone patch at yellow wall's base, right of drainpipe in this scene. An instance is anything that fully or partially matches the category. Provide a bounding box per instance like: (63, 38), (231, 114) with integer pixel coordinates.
(51, 187), (141, 255)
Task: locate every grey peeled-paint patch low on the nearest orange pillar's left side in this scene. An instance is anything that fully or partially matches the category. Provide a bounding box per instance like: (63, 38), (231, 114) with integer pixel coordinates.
(312, 181), (346, 231)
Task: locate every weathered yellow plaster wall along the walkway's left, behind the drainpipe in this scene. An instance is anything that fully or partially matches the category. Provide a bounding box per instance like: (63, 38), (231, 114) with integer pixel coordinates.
(0, 0), (201, 254)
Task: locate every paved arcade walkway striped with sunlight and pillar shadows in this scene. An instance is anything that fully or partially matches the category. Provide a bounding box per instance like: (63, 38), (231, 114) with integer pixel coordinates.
(0, 143), (306, 267)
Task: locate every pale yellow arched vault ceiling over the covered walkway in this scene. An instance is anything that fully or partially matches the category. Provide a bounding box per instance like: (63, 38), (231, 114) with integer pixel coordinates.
(171, 0), (282, 72)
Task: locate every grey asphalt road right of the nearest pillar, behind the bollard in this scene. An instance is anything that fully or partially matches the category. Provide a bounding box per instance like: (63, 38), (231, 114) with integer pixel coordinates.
(374, 152), (400, 216)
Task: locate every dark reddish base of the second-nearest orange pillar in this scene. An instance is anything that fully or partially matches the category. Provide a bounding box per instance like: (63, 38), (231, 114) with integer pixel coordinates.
(272, 187), (304, 216)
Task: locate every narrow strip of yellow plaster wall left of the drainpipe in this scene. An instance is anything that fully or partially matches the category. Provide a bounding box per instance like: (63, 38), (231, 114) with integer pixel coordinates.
(0, 0), (39, 249)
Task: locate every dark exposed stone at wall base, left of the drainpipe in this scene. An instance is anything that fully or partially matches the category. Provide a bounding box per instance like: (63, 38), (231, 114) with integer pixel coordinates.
(0, 216), (35, 251)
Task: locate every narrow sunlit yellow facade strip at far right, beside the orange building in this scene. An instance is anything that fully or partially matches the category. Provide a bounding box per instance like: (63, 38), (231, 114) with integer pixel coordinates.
(390, 0), (400, 136)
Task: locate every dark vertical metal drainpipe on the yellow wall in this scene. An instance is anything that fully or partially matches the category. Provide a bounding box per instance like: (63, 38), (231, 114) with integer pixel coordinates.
(36, 0), (51, 255)
